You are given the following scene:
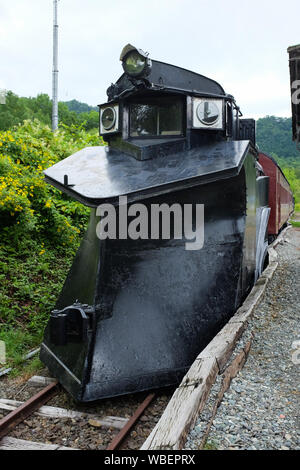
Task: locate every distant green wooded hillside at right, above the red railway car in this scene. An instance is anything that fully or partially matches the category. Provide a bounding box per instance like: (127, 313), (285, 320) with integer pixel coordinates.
(256, 116), (300, 159)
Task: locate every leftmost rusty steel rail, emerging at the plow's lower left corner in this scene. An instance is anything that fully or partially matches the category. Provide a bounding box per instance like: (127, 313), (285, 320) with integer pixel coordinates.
(0, 382), (59, 439)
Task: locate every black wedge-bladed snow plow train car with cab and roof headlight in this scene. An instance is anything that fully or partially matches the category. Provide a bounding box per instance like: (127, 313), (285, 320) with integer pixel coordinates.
(40, 45), (278, 402)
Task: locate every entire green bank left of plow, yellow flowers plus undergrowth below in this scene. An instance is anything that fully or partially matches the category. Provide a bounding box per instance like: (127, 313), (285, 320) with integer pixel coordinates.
(0, 120), (102, 364)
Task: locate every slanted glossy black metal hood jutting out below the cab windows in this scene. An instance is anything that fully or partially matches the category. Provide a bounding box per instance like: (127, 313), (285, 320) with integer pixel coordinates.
(45, 141), (249, 207)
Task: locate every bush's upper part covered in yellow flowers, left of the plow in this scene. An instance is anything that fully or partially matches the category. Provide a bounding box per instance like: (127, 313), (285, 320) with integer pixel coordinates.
(0, 121), (100, 249)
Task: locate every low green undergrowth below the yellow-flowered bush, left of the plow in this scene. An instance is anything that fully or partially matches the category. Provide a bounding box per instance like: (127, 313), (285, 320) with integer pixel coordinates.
(0, 240), (76, 376)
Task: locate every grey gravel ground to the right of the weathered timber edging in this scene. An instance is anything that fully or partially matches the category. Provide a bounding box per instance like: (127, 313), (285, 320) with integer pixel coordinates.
(185, 228), (300, 450)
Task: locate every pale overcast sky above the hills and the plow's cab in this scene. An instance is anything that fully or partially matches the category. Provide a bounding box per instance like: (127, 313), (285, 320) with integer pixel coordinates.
(0, 0), (300, 118)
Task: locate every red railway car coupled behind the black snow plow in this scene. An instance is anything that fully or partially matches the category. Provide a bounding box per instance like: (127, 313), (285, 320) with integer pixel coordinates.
(259, 152), (294, 238)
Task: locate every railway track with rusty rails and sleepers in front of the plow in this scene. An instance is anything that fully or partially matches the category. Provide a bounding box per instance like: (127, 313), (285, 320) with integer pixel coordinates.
(0, 377), (168, 450)
